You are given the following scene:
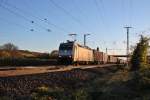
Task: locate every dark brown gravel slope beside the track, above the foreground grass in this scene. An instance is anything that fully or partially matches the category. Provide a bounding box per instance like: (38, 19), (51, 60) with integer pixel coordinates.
(0, 64), (120, 100)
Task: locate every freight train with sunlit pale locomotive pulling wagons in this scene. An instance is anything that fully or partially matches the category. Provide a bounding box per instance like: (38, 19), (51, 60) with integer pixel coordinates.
(58, 41), (125, 64)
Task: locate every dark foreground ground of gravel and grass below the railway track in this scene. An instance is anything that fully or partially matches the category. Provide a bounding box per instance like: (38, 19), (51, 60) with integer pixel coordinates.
(0, 65), (148, 100)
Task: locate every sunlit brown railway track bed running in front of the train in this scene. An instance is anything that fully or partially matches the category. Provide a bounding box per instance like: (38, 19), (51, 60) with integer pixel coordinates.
(0, 64), (120, 77)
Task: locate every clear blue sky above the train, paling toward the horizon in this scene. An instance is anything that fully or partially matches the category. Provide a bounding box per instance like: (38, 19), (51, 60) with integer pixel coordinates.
(0, 0), (150, 54)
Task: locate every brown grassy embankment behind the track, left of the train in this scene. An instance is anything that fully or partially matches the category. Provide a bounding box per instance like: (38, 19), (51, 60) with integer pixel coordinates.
(0, 50), (56, 66)
